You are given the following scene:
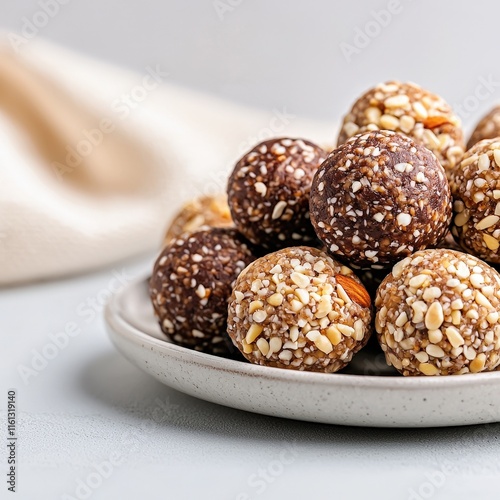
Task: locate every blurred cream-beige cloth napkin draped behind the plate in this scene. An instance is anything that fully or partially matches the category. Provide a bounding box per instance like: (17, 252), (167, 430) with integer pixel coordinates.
(0, 40), (335, 285)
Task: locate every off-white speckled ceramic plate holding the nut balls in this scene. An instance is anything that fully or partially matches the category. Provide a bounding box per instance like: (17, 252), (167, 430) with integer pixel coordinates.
(105, 279), (500, 427)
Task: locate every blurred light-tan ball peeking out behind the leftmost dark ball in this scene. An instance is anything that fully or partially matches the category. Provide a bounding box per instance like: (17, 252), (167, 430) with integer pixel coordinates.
(163, 194), (234, 248)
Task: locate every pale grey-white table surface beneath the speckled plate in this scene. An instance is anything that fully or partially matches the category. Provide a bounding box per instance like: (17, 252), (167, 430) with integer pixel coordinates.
(0, 257), (500, 500)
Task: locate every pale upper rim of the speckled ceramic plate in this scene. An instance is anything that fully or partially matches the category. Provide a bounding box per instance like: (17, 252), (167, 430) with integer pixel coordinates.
(104, 277), (500, 390)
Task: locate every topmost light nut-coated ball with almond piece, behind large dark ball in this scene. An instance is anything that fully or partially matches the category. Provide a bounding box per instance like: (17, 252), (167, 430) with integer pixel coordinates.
(337, 81), (464, 172)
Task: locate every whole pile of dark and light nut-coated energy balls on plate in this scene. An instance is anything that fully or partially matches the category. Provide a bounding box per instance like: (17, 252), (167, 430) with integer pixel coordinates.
(150, 81), (500, 375)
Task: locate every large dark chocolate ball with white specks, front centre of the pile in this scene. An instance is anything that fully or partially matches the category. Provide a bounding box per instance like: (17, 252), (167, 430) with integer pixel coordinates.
(310, 130), (451, 269)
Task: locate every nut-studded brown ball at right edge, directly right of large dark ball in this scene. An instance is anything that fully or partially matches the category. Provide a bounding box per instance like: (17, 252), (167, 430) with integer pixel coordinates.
(450, 138), (500, 264)
